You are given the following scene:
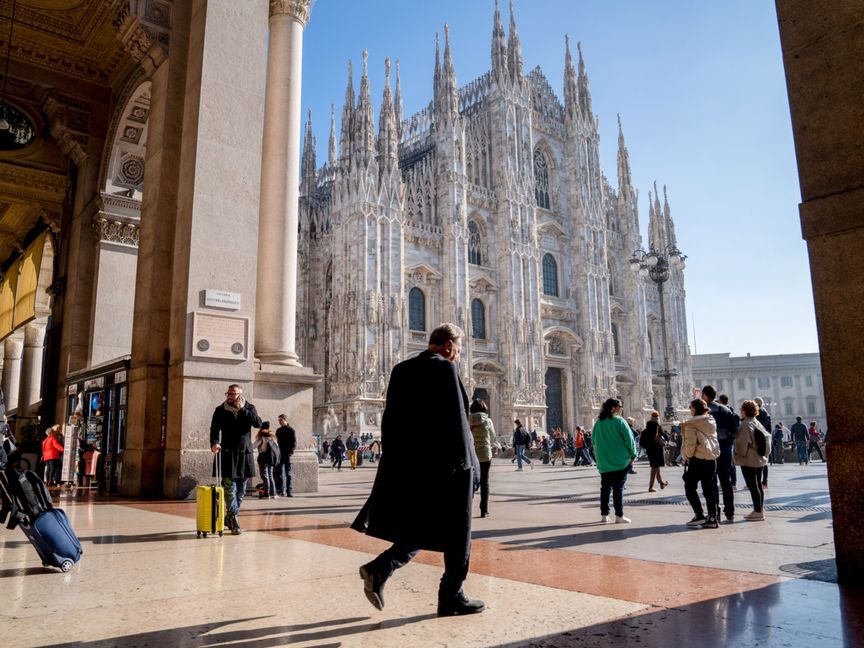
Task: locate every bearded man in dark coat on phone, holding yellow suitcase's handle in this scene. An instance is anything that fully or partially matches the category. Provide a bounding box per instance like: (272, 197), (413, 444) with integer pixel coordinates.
(210, 385), (261, 535)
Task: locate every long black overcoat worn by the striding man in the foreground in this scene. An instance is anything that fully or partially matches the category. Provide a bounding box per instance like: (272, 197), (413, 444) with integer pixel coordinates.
(351, 350), (479, 551)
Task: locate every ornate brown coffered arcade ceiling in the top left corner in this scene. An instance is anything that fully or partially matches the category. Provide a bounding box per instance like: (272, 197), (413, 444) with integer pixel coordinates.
(0, 0), (171, 274)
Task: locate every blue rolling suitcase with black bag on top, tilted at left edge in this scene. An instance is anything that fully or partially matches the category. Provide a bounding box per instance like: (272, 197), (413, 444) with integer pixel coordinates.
(0, 469), (84, 572)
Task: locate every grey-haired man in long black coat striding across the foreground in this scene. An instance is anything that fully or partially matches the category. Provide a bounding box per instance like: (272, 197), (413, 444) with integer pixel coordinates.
(352, 324), (485, 616)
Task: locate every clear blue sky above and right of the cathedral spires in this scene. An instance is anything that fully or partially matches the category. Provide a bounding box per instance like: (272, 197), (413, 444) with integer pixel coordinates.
(302, 0), (818, 355)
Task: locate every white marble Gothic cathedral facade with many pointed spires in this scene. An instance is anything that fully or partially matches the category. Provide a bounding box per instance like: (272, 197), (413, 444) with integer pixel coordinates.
(297, 2), (691, 436)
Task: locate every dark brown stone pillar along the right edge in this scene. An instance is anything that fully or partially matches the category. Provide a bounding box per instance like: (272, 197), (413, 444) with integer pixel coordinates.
(777, 0), (864, 584)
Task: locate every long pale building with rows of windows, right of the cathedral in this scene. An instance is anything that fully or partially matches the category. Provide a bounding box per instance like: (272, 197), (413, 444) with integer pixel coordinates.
(691, 353), (826, 431)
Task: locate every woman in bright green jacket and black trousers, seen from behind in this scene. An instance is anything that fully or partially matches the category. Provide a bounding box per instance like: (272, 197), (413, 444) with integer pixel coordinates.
(591, 398), (636, 524)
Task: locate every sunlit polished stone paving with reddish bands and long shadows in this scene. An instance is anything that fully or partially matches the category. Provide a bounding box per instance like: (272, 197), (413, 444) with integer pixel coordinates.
(0, 460), (864, 648)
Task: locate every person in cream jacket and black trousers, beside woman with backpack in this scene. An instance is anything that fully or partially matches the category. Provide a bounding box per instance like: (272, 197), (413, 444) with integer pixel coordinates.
(681, 398), (720, 529)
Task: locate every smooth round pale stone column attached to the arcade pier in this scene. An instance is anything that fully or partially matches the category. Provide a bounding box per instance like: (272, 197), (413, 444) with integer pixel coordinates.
(255, 0), (311, 366)
